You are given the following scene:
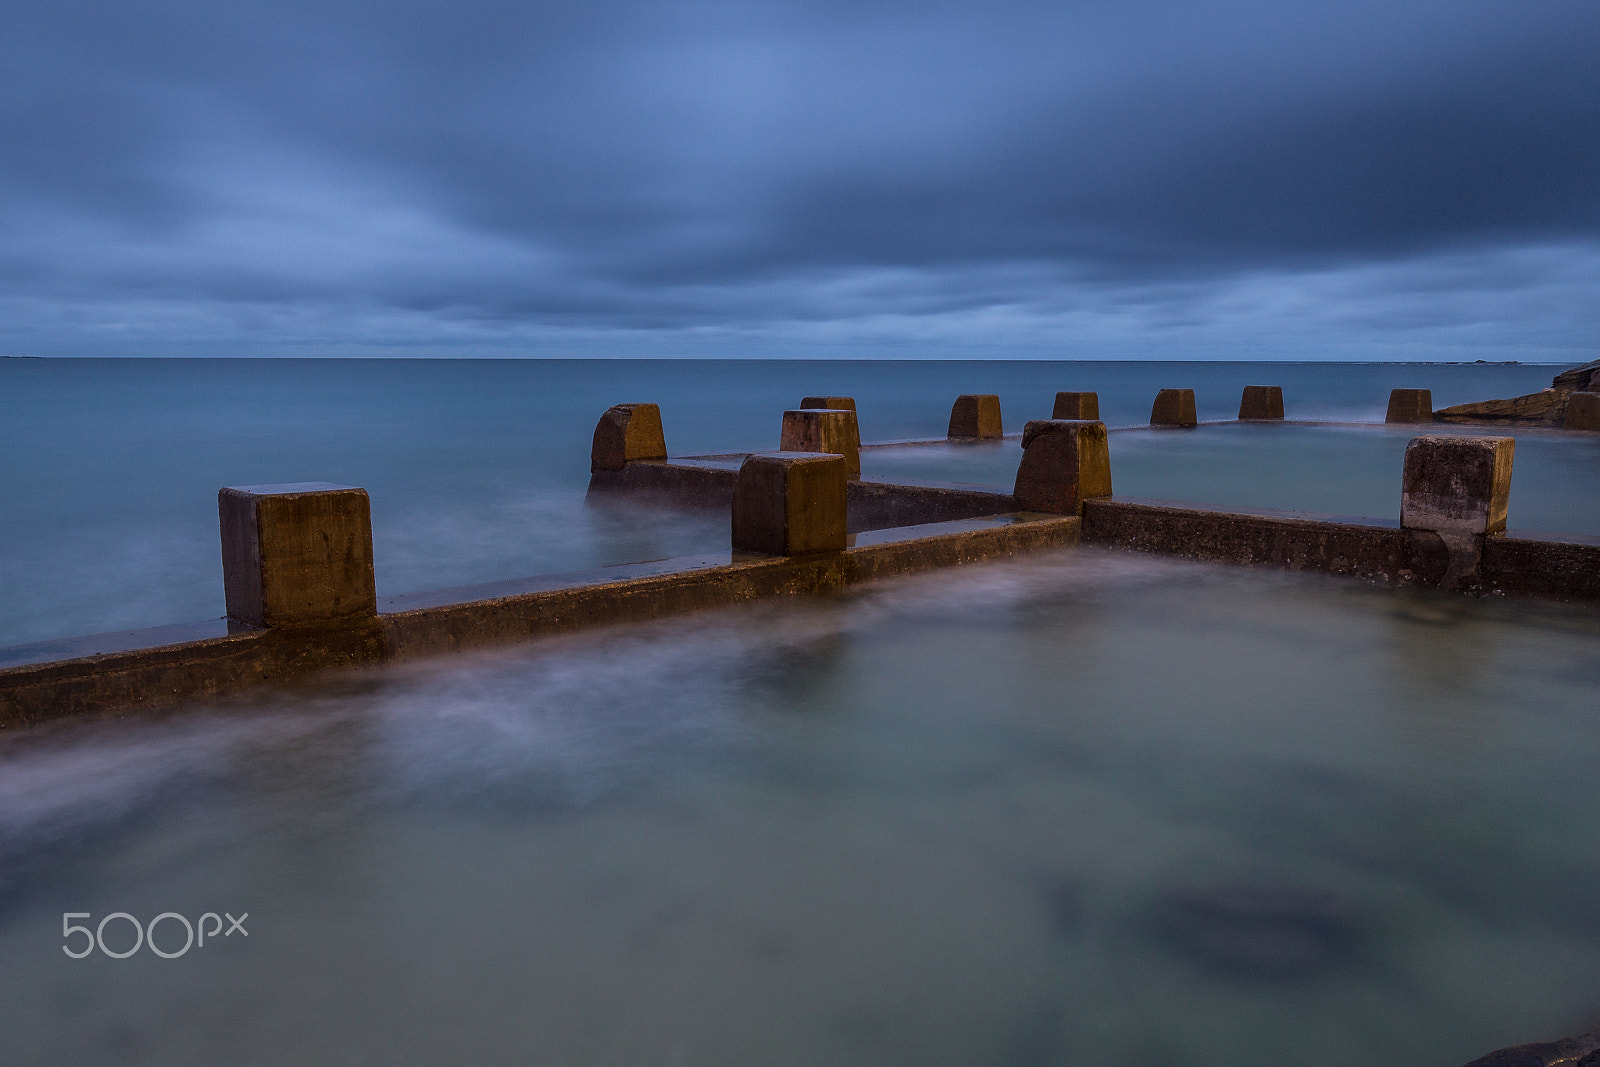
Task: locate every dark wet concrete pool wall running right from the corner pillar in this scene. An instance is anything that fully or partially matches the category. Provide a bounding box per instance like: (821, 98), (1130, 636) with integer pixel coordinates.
(1083, 499), (1600, 600)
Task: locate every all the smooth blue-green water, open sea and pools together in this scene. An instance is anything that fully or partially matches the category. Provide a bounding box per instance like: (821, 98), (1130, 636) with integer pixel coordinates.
(0, 360), (1600, 1067)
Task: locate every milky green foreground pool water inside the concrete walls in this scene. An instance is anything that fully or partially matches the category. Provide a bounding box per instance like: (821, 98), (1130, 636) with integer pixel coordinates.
(0, 549), (1600, 1067)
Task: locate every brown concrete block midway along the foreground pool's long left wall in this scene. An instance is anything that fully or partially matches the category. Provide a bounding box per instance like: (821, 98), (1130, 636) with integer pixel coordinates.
(733, 453), (846, 555)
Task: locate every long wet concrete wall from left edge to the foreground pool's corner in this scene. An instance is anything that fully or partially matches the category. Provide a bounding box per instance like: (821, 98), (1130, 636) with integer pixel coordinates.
(0, 514), (1082, 728)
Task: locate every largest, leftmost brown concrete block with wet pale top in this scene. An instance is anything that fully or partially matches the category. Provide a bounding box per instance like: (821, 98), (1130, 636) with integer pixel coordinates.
(216, 482), (378, 627)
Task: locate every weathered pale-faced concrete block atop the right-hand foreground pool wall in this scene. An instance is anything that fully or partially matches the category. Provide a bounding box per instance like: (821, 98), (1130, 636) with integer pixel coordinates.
(1400, 434), (1517, 534)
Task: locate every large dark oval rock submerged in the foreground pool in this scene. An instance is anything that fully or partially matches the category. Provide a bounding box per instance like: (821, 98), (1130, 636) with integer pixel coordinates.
(1154, 886), (1358, 981)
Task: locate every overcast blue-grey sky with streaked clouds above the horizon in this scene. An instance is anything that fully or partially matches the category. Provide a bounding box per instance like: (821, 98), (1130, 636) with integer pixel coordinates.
(0, 0), (1600, 362)
